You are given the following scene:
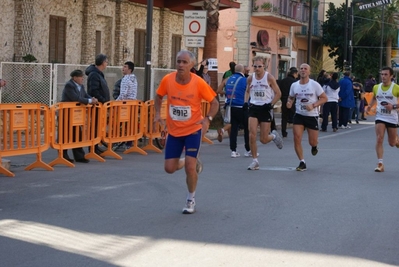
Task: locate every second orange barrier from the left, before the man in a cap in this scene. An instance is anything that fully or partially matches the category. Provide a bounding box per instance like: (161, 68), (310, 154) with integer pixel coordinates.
(49, 102), (105, 167)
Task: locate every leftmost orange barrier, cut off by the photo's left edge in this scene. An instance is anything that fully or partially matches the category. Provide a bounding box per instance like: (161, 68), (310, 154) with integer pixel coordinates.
(0, 104), (54, 177)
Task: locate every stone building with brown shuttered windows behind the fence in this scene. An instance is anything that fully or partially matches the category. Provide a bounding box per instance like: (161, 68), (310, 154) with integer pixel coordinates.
(0, 0), (241, 68)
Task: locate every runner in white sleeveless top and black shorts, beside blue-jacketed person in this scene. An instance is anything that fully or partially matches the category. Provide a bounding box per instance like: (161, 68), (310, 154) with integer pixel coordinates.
(244, 56), (283, 170)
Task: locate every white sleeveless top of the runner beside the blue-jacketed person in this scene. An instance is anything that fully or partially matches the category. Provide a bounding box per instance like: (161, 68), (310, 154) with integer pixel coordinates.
(249, 72), (274, 106)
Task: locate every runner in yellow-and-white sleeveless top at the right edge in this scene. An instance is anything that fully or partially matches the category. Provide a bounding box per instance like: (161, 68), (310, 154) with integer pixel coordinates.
(367, 67), (399, 172)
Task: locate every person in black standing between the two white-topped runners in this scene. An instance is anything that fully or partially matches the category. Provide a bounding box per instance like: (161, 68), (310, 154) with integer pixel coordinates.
(277, 67), (298, 137)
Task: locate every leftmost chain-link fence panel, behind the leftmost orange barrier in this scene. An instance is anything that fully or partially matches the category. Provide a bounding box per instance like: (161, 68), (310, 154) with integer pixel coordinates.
(0, 62), (52, 105)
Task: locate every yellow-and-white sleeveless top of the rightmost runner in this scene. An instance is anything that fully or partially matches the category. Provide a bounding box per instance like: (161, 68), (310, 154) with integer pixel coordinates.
(375, 83), (398, 124)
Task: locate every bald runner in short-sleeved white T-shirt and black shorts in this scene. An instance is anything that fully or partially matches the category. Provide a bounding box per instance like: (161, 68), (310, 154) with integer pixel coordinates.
(287, 64), (327, 171)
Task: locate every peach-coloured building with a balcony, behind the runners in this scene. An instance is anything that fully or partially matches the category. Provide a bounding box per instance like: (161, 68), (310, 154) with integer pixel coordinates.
(218, 0), (336, 78)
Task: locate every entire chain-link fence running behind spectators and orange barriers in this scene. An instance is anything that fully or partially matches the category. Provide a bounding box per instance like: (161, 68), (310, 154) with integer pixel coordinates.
(0, 62), (223, 106)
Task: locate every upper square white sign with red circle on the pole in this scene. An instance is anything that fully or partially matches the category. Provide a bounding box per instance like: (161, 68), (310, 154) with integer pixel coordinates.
(183, 10), (206, 36)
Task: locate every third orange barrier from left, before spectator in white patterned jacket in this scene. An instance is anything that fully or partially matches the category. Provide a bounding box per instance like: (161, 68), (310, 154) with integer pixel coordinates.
(101, 100), (147, 159)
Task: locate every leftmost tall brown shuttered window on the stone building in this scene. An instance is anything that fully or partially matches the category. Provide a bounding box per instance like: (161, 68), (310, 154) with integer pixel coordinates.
(49, 16), (66, 63)
